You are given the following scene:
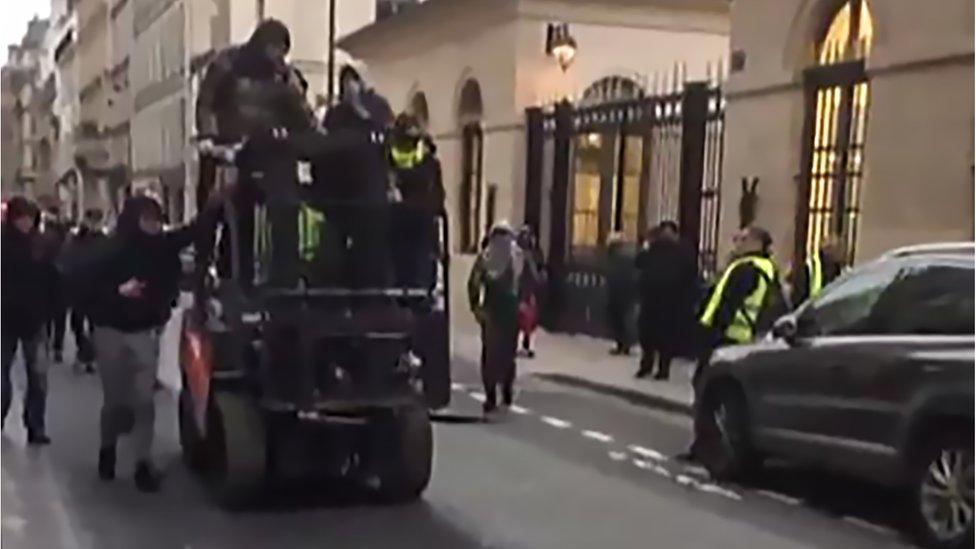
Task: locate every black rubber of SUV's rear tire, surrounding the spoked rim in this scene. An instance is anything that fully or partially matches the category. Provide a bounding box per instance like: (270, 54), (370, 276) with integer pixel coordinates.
(905, 432), (974, 549)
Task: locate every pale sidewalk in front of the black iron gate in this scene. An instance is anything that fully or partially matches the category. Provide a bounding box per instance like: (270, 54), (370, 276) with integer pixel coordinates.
(454, 330), (695, 415)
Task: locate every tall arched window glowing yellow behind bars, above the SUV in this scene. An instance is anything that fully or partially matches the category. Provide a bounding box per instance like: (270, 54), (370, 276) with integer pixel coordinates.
(795, 0), (874, 266)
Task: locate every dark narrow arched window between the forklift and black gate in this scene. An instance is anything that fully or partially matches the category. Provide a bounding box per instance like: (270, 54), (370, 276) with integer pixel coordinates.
(458, 79), (485, 252)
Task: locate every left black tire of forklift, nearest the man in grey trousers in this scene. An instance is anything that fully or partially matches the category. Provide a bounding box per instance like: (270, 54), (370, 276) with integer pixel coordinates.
(207, 392), (267, 508)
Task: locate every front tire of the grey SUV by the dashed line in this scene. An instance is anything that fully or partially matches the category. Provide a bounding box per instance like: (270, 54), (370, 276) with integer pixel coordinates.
(698, 384), (762, 482)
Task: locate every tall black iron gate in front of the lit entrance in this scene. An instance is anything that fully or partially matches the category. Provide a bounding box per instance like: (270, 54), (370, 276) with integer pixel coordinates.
(525, 83), (724, 335)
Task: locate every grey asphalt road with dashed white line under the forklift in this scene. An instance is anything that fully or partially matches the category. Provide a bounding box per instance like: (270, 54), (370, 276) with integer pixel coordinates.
(0, 350), (920, 549)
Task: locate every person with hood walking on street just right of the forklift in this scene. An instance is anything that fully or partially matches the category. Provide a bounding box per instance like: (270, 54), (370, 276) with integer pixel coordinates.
(468, 222), (534, 417)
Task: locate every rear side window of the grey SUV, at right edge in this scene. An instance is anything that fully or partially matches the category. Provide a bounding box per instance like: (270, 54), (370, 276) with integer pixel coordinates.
(871, 262), (974, 335)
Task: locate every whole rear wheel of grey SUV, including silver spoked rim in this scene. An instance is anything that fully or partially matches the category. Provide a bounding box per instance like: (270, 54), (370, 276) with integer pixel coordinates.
(909, 435), (974, 549)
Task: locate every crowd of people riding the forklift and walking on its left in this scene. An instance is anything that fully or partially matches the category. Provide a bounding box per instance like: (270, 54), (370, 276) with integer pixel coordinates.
(2, 19), (448, 492)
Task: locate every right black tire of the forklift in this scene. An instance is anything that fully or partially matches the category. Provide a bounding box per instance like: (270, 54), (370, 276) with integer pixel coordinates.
(375, 403), (434, 503)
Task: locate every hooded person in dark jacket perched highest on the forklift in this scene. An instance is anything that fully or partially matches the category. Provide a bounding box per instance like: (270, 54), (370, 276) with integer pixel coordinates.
(196, 19), (317, 292)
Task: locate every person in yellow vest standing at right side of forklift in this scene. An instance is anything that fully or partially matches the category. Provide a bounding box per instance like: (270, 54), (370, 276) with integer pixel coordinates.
(390, 113), (445, 289)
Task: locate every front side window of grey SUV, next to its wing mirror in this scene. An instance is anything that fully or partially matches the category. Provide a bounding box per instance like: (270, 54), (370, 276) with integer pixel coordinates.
(798, 263), (900, 337)
